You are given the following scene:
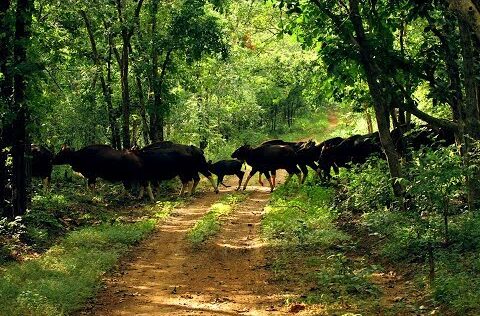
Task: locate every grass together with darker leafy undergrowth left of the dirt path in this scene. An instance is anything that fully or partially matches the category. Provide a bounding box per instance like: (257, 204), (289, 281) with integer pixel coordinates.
(0, 172), (185, 316)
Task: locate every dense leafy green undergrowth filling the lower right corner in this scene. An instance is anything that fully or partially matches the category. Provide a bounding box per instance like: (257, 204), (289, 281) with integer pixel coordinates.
(339, 147), (480, 315)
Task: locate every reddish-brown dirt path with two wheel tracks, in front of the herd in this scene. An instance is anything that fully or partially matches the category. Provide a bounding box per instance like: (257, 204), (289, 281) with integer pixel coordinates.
(84, 187), (284, 315)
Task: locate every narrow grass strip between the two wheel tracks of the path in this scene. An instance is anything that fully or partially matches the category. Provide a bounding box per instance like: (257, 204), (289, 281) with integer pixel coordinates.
(187, 192), (248, 247)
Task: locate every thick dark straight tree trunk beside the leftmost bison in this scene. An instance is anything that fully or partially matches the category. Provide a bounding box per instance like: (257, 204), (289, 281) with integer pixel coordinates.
(11, 0), (33, 217)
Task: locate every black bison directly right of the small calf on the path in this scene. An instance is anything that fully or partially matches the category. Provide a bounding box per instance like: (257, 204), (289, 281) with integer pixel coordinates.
(232, 145), (300, 191)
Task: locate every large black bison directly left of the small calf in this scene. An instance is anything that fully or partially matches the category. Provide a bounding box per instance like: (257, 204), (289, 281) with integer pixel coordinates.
(137, 141), (218, 194)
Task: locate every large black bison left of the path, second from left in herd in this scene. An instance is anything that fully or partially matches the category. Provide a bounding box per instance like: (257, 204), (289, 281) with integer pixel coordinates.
(53, 145), (154, 200)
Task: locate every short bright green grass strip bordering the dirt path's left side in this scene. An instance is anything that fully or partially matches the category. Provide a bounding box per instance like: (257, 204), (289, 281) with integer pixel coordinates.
(0, 220), (155, 316)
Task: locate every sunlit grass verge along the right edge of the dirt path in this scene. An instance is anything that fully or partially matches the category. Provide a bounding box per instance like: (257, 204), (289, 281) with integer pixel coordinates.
(262, 177), (379, 315)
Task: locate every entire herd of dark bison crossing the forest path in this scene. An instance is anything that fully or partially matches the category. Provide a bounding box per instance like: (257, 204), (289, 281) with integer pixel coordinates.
(14, 126), (454, 200)
